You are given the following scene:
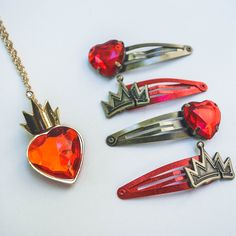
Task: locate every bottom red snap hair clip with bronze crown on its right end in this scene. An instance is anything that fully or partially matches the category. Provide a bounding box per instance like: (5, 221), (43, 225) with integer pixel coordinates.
(117, 142), (235, 199)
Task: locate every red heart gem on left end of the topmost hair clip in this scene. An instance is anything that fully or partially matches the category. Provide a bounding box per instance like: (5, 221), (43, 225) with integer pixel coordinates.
(88, 40), (125, 77)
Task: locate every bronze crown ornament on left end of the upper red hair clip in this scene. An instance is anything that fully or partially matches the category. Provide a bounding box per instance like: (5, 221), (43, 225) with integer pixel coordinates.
(101, 78), (150, 118)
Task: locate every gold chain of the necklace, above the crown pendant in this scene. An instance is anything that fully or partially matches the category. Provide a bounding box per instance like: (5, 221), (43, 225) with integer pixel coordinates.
(0, 20), (38, 104)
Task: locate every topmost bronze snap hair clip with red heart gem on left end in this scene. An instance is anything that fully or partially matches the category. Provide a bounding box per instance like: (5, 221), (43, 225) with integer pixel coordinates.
(88, 40), (192, 77)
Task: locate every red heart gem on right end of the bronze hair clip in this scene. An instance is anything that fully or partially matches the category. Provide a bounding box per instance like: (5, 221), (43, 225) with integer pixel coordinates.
(182, 100), (221, 139)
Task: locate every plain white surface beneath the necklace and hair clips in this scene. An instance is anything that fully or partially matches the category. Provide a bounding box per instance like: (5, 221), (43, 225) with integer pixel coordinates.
(0, 0), (236, 236)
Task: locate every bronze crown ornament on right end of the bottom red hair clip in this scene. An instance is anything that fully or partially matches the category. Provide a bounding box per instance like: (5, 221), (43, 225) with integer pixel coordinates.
(184, 141), (235, 188)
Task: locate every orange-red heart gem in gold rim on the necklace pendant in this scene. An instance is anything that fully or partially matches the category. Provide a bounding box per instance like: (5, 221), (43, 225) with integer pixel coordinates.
(28, 126), (83, 183)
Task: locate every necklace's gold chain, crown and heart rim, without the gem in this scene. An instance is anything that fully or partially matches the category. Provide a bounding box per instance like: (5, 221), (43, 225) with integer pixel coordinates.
(0, 20), (84, 184)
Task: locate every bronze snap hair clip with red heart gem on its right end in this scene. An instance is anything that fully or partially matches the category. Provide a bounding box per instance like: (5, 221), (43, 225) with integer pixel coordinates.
(106, 100), (221, 146)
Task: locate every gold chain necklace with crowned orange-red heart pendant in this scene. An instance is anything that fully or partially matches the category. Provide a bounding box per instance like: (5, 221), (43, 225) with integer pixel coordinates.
(0, 20), (83, 184)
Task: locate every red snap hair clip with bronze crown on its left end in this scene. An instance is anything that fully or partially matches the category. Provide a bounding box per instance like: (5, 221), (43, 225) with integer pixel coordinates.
(102, 75), (207, 118)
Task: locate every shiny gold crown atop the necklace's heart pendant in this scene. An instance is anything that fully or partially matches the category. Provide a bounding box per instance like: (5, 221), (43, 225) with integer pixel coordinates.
(21, 100), (60, 135)
